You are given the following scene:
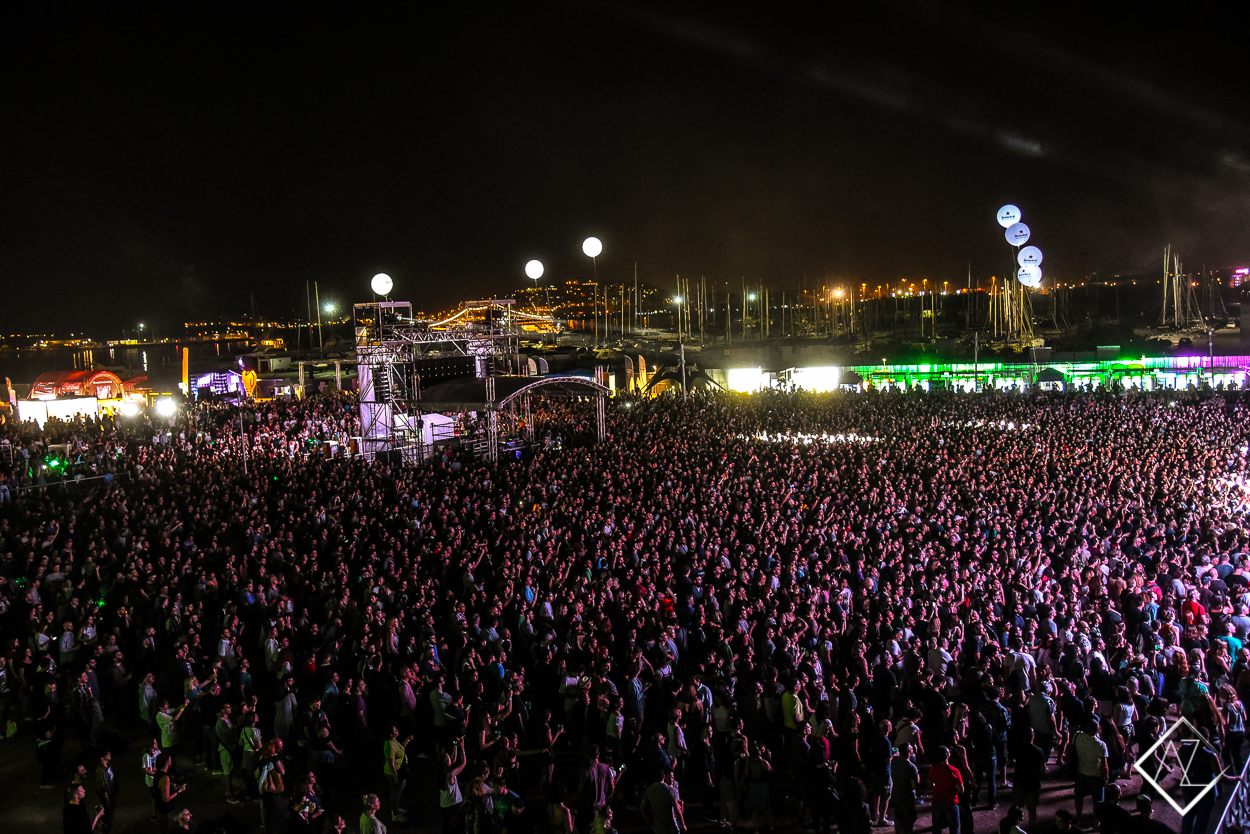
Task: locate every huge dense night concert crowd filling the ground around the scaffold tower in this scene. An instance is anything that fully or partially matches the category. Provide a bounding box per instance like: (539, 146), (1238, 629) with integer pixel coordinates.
(0, 393), (1250, 834)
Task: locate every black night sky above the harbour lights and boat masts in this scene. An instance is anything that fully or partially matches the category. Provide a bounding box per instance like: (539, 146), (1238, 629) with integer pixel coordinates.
(0, 3), (1250, 335)
